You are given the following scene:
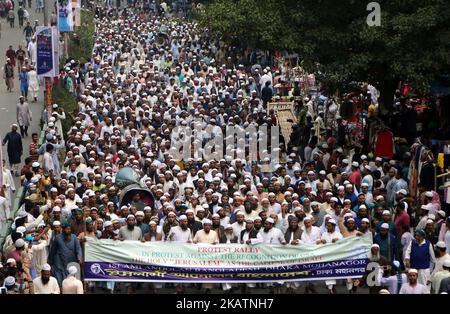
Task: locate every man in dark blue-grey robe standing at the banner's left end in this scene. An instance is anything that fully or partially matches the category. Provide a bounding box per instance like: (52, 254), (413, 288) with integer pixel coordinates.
(48, 222), (82, 285)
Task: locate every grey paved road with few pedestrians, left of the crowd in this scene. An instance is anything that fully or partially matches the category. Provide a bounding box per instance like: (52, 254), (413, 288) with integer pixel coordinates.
(0, 1), (44, 188)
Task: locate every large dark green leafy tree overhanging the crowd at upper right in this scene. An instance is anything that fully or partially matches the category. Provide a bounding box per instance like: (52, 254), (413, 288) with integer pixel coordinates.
(198, 0), (450, 108)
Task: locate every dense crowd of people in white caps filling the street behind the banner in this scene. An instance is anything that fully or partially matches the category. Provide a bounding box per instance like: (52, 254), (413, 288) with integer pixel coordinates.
(0, 3), (450, 294)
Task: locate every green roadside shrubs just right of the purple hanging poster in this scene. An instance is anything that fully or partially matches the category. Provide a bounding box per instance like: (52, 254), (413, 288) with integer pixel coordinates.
(68, 9), (95, 63)
